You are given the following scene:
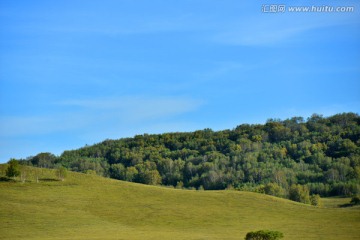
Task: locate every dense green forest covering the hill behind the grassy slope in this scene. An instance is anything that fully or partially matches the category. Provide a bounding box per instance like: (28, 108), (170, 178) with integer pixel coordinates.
(17, 113), (360, 202)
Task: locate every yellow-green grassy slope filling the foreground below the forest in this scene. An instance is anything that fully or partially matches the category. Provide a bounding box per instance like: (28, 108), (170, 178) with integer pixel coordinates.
(0, 169), (360, 239)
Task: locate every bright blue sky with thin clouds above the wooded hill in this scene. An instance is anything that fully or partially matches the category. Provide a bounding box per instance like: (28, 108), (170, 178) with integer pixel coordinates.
(0, 0), (360, 162)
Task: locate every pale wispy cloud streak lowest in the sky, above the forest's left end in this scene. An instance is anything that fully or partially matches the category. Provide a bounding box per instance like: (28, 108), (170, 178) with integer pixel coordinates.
(0, 96), (204, 137)
